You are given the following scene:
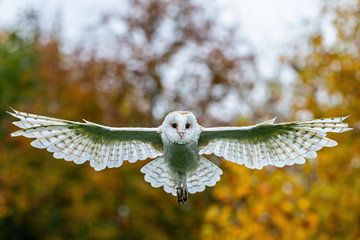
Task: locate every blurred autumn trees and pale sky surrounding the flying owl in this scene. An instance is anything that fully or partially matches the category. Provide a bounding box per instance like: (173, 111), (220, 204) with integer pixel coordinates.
(0, 0), (360, 239)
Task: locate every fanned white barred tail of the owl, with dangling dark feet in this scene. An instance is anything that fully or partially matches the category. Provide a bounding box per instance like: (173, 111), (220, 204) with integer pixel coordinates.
(140, 156), (222, 203)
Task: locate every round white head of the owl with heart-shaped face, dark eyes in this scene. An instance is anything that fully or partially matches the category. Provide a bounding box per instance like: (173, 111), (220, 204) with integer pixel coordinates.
(161, 111), (199, 144)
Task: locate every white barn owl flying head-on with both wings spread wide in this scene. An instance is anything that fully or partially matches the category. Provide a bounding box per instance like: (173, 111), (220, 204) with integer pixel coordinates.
(8, 109), (351, 203)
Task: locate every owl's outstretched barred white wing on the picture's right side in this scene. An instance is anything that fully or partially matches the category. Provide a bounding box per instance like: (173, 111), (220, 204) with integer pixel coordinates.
(199, 117), (351, 169)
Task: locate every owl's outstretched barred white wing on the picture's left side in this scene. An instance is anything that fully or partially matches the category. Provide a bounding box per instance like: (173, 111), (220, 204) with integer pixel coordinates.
(8, 110), (162, 171)
